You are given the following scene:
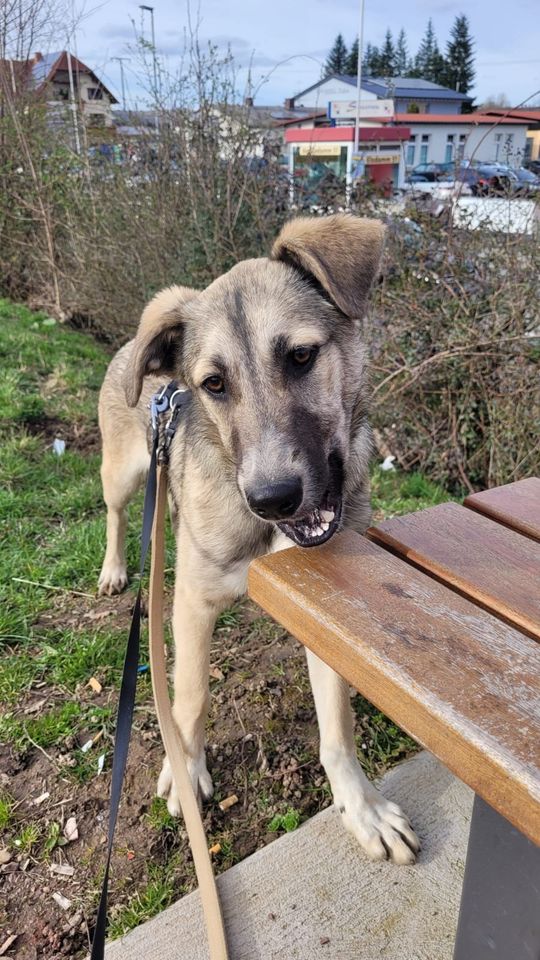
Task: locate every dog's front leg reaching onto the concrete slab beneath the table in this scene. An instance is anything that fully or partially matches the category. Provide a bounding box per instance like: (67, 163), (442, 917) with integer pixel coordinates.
(306, 650), (420, 864)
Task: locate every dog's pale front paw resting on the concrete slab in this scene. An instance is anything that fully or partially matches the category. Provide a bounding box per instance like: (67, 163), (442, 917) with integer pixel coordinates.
(338, 790), (420, 865)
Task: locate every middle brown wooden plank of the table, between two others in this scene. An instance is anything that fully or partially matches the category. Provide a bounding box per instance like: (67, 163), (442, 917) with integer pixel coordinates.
(367, 503), (540, 639)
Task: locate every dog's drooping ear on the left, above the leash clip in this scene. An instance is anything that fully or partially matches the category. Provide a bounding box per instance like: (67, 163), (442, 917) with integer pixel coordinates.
(124, 287), (197, 407)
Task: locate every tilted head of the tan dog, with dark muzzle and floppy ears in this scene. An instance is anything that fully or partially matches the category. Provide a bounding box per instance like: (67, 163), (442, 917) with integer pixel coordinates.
(125, 214), (384, 546)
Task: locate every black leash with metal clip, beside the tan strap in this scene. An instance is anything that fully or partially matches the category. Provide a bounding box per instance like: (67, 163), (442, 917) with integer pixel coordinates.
(90, 380), (191, 960)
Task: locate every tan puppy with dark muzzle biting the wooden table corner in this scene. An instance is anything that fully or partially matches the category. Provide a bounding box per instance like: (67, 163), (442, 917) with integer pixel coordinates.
(99, 214), (419, 864)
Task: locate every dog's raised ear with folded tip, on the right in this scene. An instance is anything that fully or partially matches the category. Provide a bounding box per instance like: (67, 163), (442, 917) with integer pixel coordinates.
(272, 213), (385, 318)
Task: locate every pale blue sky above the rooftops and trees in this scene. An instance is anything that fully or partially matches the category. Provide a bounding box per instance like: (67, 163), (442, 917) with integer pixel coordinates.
(59, 0), (540, 107)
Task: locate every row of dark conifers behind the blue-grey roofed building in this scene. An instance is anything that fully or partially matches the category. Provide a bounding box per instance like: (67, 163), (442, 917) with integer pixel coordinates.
(324, 14), (475, 93)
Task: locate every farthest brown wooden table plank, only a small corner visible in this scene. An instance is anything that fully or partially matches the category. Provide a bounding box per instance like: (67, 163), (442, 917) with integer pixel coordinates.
(464, 477), (540, 540)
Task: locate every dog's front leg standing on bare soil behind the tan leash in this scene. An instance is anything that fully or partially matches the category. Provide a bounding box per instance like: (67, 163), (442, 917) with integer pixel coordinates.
(157, 578), (225, 816)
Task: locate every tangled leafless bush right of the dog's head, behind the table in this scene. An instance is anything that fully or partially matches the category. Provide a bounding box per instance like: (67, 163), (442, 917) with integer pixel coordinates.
(366, 217), (540, 490)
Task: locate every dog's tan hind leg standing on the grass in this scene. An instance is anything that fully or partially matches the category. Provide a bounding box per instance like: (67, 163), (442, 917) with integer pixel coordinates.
(98, 433), (150, 596)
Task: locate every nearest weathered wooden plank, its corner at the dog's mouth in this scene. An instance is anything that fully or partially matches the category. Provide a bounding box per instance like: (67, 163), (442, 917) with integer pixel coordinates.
(249, 531), (540, 843)
